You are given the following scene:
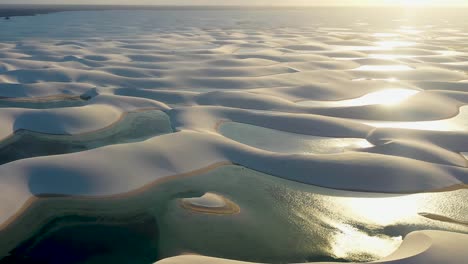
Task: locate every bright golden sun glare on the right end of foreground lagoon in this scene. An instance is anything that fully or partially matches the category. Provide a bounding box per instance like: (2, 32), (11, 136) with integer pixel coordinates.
(276, 179), (468, 261)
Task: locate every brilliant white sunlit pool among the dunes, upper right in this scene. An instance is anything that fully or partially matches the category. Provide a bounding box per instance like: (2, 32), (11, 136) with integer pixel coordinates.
(297, 88), (419, 107)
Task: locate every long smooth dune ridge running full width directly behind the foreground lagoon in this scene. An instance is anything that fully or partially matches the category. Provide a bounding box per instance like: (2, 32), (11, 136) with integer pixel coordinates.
(0, 129), (468, 227)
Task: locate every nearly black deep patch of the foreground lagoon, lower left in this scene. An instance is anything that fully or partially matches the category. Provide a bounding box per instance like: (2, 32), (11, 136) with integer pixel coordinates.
(0, 215), (158, 264)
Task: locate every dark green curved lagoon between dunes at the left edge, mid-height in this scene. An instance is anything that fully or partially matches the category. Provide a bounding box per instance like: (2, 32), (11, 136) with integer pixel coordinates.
(0, 110), (173, 164)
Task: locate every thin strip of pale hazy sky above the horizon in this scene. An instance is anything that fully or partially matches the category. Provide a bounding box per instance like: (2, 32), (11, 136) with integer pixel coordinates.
(0, 0), (468, 6)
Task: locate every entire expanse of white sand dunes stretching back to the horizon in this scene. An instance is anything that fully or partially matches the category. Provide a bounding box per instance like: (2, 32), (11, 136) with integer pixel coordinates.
(0, 7), (468, 264)
